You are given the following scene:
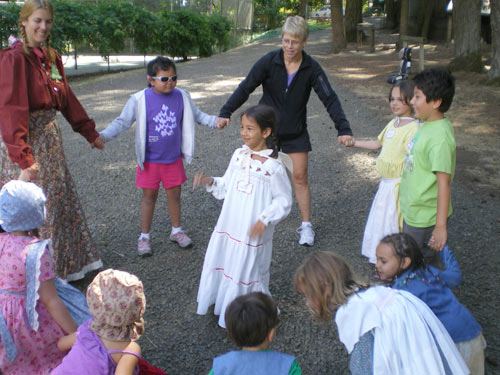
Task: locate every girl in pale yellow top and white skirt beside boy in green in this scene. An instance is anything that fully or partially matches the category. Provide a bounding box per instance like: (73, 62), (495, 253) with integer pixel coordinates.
(354, 80), (418, 264)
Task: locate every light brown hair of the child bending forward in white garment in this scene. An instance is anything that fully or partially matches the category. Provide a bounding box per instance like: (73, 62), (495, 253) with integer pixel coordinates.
(293, 251), (370, 320)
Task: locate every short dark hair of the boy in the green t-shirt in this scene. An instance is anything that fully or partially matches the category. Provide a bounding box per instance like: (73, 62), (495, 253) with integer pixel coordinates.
(413, 68), (455, 113)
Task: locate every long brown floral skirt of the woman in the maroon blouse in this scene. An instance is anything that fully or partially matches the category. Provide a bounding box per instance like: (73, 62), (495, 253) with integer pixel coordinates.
(0, 110), (102, 281)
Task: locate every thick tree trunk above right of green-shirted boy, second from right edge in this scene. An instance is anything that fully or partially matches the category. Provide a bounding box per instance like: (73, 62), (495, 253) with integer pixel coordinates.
(450, 0), (483, 72)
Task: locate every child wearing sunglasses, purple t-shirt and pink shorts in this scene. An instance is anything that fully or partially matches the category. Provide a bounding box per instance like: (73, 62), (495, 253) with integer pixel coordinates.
(100, 56), (222, 256)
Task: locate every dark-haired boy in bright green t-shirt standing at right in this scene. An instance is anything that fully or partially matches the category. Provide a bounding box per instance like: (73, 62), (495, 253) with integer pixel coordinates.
(399, 69), (456, 262)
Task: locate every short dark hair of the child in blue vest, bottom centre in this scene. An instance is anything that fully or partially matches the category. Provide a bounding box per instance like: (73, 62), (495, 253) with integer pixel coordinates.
(224, 292), (279, 347)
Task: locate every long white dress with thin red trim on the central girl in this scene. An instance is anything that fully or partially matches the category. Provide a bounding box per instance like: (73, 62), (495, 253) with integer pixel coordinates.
(197, 146), (292, 328)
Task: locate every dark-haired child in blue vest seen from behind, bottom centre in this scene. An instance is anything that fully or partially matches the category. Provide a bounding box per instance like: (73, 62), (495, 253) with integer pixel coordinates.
(209, 292), (302, 375)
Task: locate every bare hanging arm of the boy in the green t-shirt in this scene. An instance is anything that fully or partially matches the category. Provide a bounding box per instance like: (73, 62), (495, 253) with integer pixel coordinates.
(429, 172), (451, 251)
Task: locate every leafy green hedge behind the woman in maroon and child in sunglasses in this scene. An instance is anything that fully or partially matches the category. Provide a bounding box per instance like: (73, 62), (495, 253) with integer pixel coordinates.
(0, 0), (231, 61)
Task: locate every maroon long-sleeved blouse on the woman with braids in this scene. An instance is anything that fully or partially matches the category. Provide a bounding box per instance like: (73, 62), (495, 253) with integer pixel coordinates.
(0, 42), (99, 169)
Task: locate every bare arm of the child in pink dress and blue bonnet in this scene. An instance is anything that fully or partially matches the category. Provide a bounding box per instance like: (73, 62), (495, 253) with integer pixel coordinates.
(38, 279), (78, 334)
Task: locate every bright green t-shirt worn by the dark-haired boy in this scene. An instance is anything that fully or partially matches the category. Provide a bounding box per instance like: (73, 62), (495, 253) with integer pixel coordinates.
(399, 118), (456, 228)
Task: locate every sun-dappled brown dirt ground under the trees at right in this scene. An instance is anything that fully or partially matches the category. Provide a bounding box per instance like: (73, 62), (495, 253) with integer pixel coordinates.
(321, 25), (500, 200)
